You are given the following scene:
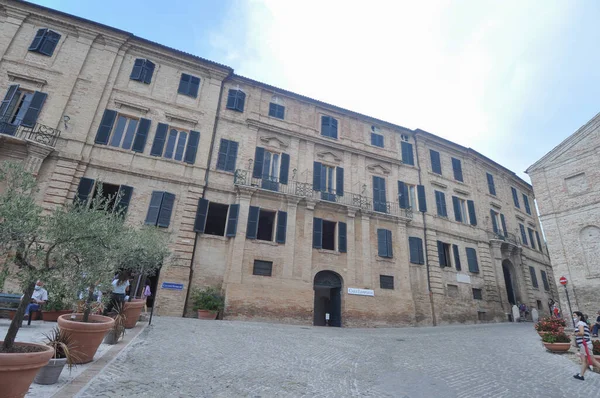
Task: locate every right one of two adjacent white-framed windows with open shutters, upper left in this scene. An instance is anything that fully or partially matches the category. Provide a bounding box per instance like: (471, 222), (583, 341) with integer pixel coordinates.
(149, 123), (200, 164)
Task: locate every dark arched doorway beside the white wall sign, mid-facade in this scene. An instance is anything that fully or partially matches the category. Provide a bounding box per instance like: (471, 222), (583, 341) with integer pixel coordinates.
(313, 271), (342, 327)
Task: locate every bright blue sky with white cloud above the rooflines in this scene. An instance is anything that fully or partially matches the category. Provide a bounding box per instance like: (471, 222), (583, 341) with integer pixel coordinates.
(33, 0), (600, 181)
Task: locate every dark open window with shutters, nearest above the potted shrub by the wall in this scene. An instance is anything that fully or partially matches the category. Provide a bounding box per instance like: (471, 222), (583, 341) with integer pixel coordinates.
(194, 198), (240, 237)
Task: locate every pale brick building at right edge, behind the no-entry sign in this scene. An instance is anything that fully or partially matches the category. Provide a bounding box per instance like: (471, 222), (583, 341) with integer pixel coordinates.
(527, 114), (600, 315)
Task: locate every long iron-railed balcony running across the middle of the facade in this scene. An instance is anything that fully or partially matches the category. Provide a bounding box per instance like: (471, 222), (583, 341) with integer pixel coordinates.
(233, 169), (413, 220)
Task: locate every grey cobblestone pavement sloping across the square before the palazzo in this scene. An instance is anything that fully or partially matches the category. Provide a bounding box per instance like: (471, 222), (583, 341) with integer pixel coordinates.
(79, 317), (600, 398)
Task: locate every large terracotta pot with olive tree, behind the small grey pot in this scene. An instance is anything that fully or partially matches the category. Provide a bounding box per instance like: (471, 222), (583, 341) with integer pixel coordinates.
(58, 314), (115, 364)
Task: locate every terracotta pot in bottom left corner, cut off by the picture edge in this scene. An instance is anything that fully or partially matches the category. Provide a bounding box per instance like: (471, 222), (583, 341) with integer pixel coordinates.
(0, 341), (54, 398)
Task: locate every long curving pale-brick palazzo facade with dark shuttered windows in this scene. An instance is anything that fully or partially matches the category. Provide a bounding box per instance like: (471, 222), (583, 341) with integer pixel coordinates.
(0, 0), (557, 326)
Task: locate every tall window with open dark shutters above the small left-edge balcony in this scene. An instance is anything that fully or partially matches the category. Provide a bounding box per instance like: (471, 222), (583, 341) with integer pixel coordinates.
(0, 84), (48, 135)
